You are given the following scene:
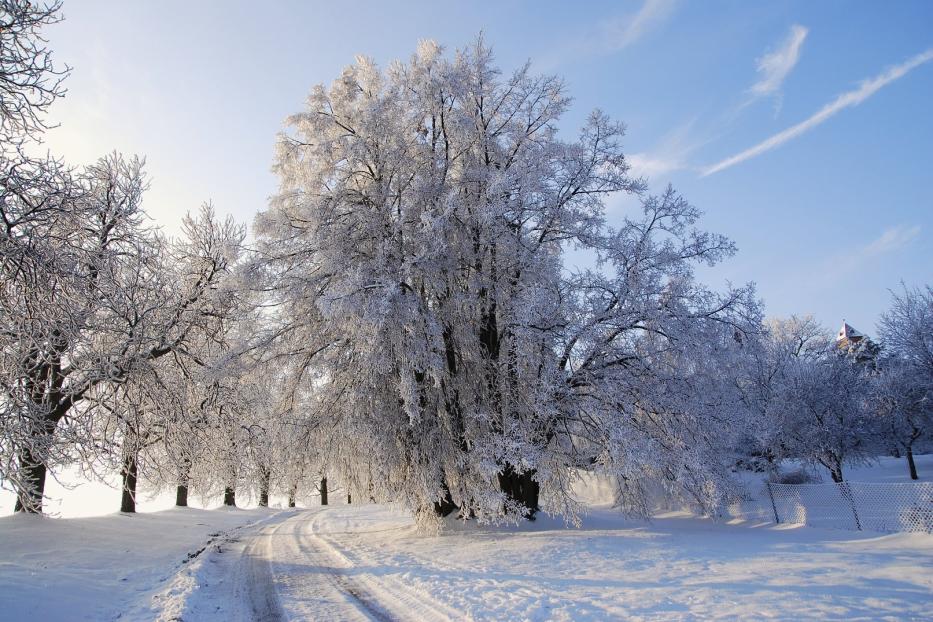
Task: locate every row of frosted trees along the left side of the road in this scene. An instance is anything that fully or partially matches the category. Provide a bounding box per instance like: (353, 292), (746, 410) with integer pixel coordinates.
(0, 0), (316, 512)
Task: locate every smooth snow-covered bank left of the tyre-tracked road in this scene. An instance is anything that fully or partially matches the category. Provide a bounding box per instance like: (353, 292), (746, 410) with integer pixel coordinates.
(0, 508), (276, 620)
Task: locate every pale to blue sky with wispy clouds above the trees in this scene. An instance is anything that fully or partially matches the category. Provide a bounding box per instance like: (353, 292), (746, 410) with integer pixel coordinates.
(40, 0), (933, 334)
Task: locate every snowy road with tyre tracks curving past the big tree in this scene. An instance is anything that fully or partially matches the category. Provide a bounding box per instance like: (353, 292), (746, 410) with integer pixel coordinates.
(164, 506), (462, 622)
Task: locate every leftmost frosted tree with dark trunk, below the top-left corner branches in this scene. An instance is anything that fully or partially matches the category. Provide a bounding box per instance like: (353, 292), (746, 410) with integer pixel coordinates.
(0, 173), (240, 511)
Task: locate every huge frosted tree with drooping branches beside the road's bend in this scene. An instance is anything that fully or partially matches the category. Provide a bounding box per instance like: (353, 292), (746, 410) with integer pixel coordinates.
(257, 40), (759, 519)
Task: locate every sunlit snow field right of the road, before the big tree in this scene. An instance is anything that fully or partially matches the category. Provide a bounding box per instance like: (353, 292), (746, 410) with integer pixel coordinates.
(300, 506), (933, 620)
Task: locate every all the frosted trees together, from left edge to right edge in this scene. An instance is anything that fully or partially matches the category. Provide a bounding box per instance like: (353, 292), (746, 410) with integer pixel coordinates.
(0, 0), (931, 521)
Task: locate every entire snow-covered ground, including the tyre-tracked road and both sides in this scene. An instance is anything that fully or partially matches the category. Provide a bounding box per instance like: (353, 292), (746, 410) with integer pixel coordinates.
(0, 456), (933, 622)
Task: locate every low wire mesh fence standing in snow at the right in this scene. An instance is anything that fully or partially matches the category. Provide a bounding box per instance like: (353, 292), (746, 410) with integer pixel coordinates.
(729, 482), (933, 533)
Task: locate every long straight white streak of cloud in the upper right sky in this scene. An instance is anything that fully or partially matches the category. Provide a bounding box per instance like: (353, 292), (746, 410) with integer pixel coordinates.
(701, 48), (933, 177)
